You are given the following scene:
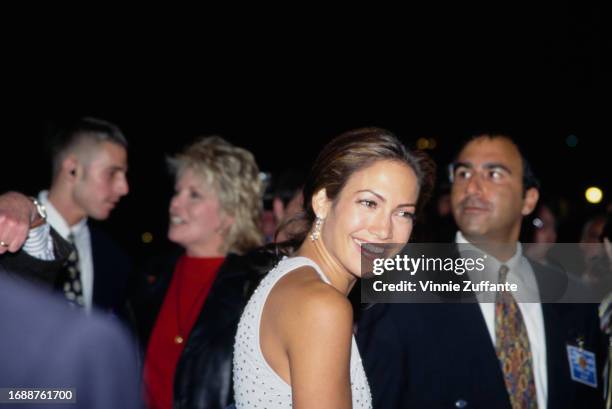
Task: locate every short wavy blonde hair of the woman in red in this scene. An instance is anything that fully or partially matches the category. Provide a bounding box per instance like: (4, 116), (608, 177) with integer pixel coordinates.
(168, 136), (264, 254)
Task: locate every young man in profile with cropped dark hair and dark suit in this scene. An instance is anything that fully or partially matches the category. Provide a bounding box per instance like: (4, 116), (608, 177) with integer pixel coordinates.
(38, 118), (131, 313)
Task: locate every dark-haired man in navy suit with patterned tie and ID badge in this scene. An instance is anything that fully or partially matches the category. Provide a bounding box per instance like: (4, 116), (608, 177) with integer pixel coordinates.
(358, 135), (606, 409)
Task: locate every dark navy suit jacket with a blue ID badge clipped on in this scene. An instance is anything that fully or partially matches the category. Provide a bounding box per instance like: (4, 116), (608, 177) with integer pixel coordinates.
(357, 256), (607, 409)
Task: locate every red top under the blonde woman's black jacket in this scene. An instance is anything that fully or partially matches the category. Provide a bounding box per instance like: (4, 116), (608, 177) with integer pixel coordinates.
(144, 256), (224, 409)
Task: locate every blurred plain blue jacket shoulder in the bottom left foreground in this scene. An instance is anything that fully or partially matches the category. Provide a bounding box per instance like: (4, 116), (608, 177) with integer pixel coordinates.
(0, 274), (141, 409)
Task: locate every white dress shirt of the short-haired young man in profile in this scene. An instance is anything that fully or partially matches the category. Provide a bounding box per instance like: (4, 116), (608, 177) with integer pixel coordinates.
(38, 190), (94, 311)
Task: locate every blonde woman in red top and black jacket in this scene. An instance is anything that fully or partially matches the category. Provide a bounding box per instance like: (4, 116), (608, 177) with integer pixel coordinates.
(136, 137), (263, 409)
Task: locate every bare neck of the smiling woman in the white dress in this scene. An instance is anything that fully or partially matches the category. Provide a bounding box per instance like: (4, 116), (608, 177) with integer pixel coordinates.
(296, 236), (357, 295)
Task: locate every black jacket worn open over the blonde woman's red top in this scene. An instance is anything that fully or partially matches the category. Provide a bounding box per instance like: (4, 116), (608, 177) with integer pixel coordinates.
(133, 245), (274, 409)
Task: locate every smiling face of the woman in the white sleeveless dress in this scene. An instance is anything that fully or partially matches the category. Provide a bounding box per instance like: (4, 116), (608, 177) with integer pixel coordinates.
(313, 160), (419, 277)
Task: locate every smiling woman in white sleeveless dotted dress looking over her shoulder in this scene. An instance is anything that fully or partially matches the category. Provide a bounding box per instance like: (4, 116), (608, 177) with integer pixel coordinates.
(233, 128), (427, 409)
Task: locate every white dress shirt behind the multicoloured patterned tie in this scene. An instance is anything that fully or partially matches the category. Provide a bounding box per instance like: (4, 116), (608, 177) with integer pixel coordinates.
(455, 232), (548, 408)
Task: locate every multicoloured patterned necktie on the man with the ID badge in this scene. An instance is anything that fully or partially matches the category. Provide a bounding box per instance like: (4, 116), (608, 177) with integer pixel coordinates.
(495, 265), (538, 409)
